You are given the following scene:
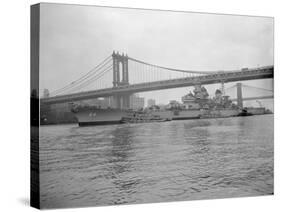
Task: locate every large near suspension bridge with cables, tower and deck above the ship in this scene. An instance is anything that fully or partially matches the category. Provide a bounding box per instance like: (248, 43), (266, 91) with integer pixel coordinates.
(41, 52), (274, 108)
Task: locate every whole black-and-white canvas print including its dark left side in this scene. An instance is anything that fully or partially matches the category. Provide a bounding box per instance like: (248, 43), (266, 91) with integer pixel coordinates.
(30, 3), (274, 209)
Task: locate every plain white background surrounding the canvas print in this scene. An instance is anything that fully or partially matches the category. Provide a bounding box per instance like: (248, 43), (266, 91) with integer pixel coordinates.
(0, 0), (281, 212)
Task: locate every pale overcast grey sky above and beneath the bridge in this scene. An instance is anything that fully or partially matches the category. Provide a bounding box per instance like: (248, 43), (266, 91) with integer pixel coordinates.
(40, 4), (274, 108)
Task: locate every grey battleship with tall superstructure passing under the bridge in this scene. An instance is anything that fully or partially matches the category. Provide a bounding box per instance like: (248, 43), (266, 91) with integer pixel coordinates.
(71, 85), (267, 126)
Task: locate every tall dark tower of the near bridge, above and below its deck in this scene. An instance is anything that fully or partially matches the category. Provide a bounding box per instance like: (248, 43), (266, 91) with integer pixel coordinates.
(112, 51), (130, 108)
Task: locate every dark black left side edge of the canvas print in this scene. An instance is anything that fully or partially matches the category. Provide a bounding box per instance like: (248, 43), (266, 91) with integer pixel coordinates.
(30, 4), (40, 209)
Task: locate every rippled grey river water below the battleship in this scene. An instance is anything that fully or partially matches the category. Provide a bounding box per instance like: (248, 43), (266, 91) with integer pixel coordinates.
(40, 115), (273, 208)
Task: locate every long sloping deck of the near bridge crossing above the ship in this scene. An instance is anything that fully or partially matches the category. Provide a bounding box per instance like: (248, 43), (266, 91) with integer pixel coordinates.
(41, 66), (274, 104)
